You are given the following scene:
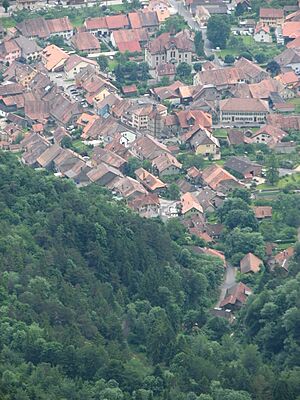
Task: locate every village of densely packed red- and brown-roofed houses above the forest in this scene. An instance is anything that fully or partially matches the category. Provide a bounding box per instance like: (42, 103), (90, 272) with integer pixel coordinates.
(0, 0), (300, 318)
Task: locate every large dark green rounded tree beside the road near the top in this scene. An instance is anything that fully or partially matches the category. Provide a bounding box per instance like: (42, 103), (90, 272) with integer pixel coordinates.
(207, 15), (230, 49)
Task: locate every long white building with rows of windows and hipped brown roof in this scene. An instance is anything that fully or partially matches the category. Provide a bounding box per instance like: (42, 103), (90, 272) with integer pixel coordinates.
(220, 98), (269, 126)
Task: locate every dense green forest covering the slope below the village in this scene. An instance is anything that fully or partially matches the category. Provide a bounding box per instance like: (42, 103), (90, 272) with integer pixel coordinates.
(0, 153), (300, 400)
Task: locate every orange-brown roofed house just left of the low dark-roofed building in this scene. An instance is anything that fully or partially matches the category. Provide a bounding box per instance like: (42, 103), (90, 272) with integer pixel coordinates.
(202, 164), (238, 190)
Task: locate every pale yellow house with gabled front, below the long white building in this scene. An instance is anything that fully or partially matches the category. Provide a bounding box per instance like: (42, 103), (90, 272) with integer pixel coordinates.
(183, 126), (221, 160)
